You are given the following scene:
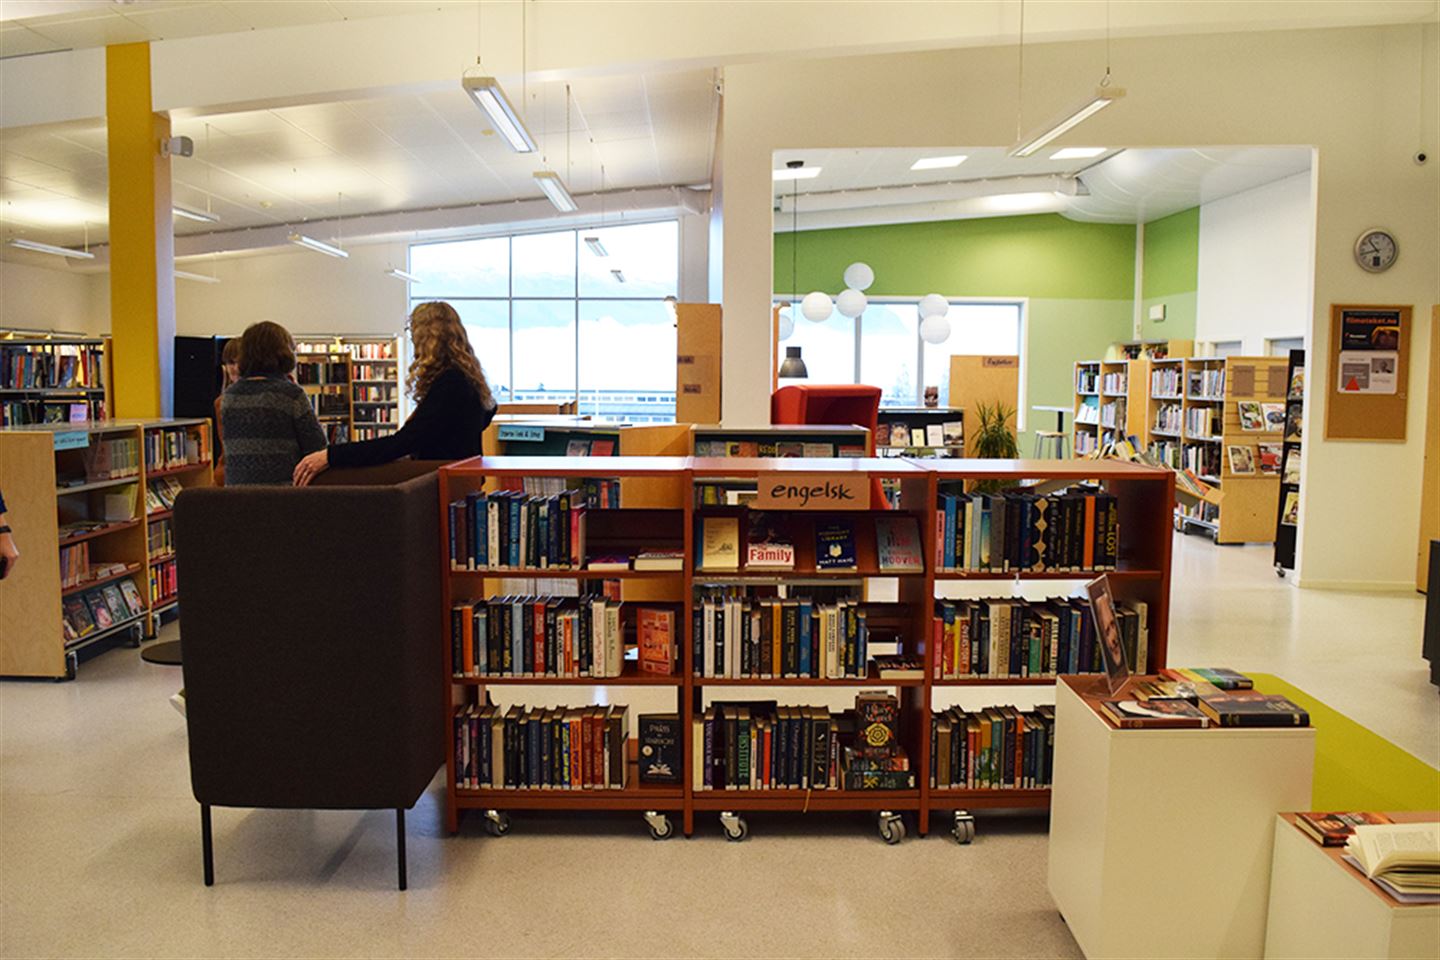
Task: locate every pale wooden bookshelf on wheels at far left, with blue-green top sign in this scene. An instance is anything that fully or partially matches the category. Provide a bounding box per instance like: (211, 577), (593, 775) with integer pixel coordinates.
(0, 419), (213, 679)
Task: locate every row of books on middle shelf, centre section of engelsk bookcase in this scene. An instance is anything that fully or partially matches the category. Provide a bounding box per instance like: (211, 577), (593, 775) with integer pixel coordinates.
(690, 590), (870, 679)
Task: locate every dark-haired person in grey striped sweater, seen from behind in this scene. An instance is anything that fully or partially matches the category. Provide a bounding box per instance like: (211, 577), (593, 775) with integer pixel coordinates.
(220, 320), (325, 486)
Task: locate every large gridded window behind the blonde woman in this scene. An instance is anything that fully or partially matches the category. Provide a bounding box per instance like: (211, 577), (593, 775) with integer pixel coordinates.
(410, 220), (680, 423)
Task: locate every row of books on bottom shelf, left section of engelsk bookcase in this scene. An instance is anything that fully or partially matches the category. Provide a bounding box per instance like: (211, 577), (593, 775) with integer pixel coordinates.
(454, 704), (629, 790)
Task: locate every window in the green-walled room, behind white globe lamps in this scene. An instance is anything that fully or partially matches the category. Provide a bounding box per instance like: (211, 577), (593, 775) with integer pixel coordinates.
(776, 298), (1025, 406)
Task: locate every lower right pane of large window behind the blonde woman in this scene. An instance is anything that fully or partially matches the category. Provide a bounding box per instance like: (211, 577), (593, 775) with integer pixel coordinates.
(580, 299), (675, 423)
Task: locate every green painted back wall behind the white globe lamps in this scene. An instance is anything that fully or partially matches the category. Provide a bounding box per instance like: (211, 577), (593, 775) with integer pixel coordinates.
(775, 213), (1135, 455)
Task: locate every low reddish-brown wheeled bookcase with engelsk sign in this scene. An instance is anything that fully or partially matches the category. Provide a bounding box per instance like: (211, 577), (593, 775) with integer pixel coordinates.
(439, 456), (1175, 842)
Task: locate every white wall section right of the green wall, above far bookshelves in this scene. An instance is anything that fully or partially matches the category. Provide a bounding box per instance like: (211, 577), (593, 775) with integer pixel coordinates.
(1195, 173), (1315, 356)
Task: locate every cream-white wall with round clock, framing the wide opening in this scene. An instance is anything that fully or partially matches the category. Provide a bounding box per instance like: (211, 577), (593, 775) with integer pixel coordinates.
(719, 24), (1440, 590)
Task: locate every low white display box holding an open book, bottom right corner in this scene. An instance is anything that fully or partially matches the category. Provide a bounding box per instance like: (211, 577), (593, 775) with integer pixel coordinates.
(1264, 812), (1440, 959)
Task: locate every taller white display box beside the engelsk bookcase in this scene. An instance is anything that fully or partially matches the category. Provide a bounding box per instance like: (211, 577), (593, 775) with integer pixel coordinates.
(1050, 676), (1315, 957)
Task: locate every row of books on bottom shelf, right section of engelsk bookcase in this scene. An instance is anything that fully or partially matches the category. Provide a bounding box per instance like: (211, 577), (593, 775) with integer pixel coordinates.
(929, 704), (1056, 790)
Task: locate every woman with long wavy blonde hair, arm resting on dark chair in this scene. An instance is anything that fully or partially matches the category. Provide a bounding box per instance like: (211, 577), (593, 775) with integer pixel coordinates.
(295, 301), (495, 486)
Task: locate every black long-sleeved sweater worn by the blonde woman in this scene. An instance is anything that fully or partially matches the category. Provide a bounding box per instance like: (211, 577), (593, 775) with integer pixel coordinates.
(330, 368), (495, 466)
